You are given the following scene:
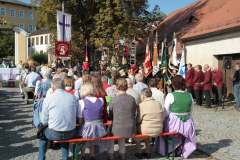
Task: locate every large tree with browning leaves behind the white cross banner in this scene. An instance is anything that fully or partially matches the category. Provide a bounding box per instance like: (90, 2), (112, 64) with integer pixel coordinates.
(32, 0), (157, 63)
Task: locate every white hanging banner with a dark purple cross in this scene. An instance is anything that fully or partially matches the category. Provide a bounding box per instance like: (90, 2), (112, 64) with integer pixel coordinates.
(57, 10), (72, 41)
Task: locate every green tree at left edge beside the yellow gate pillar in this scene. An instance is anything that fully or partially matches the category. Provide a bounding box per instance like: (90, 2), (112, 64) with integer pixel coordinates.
(0, 22), (18, 57)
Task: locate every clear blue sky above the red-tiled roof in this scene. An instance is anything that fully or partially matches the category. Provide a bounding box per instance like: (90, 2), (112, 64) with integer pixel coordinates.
(20, 0), (198, 15)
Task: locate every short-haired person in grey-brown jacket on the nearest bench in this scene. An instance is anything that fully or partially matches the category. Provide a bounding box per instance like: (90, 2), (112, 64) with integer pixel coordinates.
(108, 78), (137, 160)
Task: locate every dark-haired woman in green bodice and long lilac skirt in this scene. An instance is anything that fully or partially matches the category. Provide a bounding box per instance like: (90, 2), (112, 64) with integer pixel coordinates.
(156, 75), (196, 158)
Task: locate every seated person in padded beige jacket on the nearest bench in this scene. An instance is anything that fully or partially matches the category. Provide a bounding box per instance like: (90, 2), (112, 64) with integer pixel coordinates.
(134, 88), (165, 159)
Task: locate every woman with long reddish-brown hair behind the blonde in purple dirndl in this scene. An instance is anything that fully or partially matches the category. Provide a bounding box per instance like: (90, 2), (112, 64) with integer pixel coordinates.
(92, 76), (108, 123)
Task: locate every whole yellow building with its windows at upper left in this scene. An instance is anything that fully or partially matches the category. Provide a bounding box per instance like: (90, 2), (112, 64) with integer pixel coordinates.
(0, 0), (38, 32)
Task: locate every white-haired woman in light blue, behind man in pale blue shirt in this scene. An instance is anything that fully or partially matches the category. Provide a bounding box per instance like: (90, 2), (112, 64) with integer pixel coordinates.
(35, 66), (52, 99)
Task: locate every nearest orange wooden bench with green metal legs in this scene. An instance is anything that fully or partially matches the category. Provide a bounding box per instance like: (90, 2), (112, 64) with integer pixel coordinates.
(53, 128), (179, 160)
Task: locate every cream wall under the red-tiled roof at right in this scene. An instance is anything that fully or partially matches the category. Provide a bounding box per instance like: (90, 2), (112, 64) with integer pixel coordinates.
(185, 31), (240, 67)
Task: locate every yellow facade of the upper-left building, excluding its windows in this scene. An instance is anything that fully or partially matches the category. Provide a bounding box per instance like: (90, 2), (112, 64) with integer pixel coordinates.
(0, 2), (38, 32)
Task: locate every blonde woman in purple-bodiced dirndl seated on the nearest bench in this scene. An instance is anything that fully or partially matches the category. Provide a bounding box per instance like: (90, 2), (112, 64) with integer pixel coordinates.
(77, 82), (110, 160)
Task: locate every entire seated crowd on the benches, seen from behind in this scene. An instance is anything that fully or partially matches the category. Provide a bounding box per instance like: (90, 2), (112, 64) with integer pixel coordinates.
(20, 66), (196, 160)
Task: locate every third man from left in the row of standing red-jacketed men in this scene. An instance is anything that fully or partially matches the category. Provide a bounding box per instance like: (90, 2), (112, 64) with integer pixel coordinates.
(202, 64), (212, 108)
